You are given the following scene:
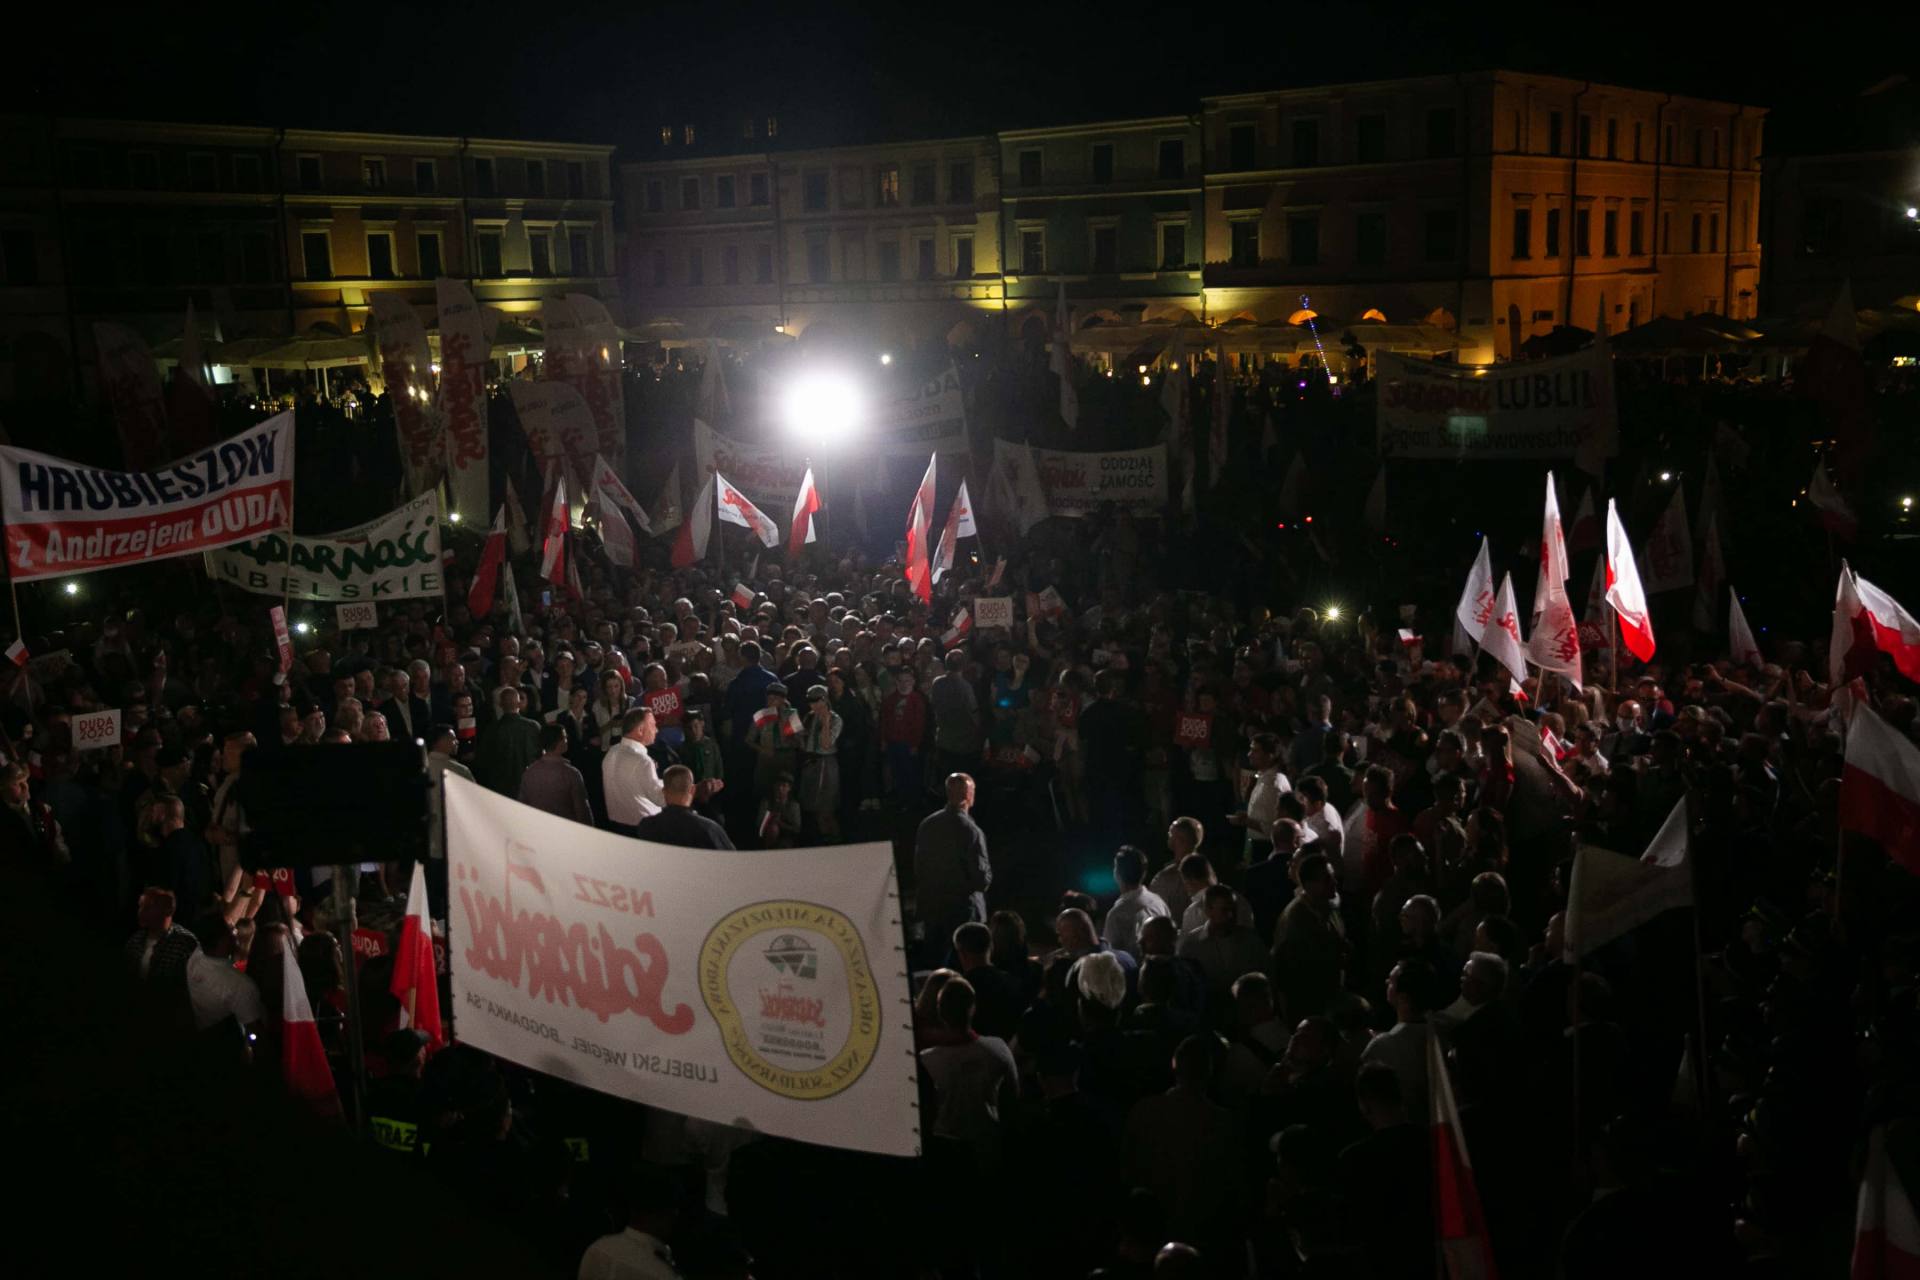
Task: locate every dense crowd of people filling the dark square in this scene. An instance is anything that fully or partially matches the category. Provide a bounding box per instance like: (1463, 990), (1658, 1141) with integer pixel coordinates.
(4, 333), (1920, 1278)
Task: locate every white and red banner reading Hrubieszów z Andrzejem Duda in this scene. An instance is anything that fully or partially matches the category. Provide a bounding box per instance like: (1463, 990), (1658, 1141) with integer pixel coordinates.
(0, 411), (294, 581)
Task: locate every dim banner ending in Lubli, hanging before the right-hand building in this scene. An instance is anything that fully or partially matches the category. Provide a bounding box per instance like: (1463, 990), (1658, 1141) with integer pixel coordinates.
(1375, 344), (1619, 461)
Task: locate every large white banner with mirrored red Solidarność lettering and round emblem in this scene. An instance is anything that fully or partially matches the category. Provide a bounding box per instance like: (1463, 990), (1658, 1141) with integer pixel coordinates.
(445, 775), (920, 1155)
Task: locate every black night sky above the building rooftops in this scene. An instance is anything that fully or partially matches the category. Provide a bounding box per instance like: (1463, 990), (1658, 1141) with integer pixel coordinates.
(15, 0), (1899, 150)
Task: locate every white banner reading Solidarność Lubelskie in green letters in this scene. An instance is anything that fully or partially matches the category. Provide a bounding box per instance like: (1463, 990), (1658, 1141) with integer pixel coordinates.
(207, 491), (445, 606)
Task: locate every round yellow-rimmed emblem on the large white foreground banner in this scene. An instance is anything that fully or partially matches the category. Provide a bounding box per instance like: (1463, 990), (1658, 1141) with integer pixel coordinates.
(699, 902), (881, 1102)
